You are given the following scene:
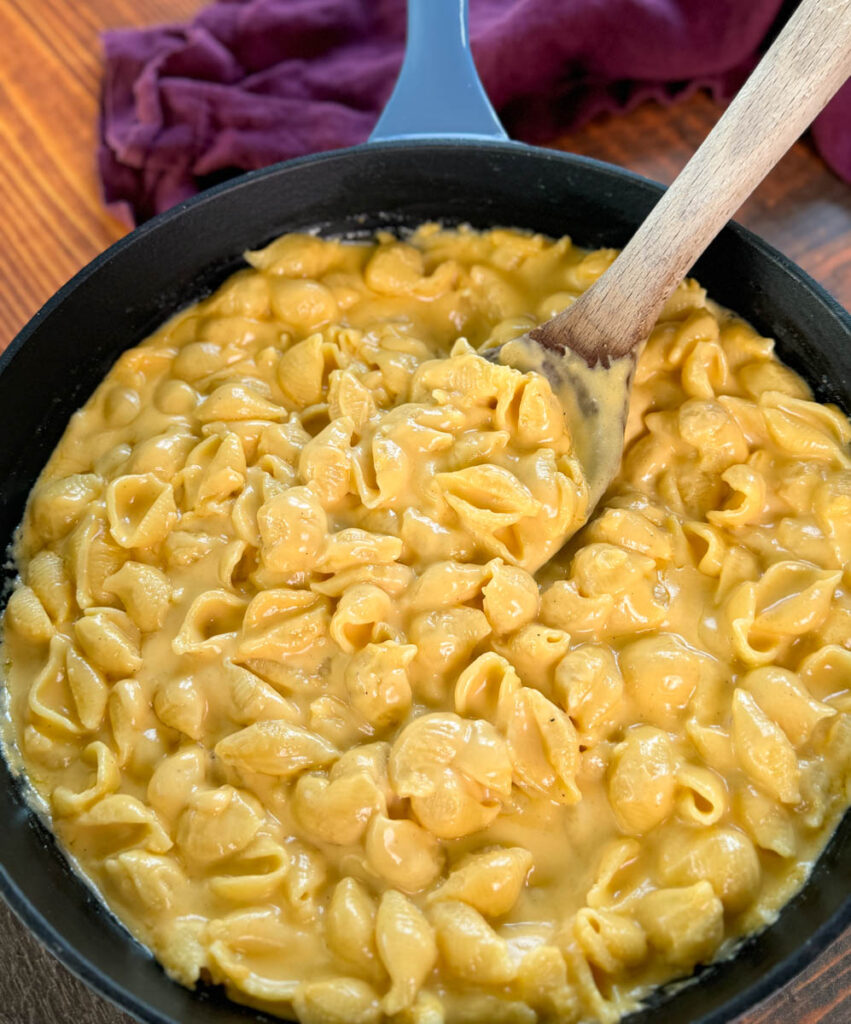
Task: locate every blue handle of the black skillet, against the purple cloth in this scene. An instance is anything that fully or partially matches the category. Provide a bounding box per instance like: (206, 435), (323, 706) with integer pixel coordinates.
(370, 0), (508, 142)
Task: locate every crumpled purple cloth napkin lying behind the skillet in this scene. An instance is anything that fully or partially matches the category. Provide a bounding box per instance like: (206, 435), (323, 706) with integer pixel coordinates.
(98, 0), (851, 222)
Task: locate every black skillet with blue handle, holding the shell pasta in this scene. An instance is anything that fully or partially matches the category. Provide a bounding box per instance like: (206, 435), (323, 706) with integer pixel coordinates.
(0, 0), (851, 1024)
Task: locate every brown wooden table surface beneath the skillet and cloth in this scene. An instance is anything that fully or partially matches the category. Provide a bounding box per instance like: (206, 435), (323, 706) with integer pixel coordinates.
(0, 0), (851, 1024)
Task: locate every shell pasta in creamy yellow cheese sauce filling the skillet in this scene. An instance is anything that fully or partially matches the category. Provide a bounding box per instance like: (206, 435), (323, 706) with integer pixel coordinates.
(4, 224), (851, 1024)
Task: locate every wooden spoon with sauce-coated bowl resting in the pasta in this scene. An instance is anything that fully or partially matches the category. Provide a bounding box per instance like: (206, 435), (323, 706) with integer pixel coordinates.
(491, 0), (851, 540)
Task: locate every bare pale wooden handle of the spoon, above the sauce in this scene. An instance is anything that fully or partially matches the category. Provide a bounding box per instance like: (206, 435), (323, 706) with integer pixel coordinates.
(534, 0), (851, 362)
